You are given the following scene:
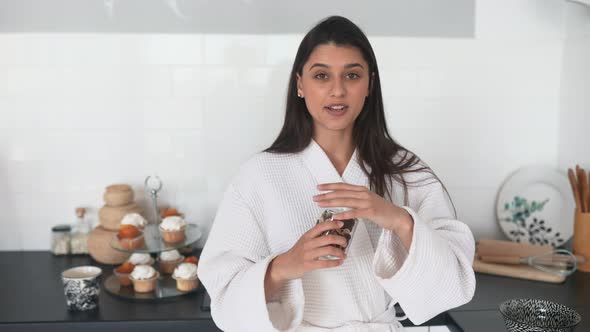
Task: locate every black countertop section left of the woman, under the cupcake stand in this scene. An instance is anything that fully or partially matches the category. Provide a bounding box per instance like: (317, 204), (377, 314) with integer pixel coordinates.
(0, 251), (219, 332)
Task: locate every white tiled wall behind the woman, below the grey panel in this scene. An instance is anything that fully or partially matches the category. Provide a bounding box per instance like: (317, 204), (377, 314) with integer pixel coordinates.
(0, 0), (576, 250)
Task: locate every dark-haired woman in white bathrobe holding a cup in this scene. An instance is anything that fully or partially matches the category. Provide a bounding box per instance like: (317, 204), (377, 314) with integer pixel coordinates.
(198, 17), (475, 331)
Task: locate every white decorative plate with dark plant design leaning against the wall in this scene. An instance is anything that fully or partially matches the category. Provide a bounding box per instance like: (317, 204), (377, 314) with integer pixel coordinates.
(496, 166), (575, 247)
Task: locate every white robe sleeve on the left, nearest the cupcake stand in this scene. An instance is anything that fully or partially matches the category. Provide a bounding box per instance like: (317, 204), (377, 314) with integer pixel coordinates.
(197, 185), (304, 331)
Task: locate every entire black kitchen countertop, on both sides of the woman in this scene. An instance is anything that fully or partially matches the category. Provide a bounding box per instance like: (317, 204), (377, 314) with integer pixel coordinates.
(0, 251), (590, 332)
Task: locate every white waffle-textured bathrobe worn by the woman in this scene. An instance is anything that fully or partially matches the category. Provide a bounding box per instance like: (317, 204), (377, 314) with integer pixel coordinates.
(198, 140), (475, 332)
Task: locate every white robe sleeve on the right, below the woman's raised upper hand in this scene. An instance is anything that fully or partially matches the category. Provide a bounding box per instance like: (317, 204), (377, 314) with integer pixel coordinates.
(373, 182), (475, 325)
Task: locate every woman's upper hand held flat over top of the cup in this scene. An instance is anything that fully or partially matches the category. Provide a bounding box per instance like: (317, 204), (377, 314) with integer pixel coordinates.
(313, 183), (413, 235)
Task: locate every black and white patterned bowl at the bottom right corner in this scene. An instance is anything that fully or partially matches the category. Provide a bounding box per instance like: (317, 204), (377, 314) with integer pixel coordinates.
(500, 299), (582, 332)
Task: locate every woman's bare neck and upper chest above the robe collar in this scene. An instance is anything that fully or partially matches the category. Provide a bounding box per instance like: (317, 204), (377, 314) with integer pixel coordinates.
(313, 131), (355, 176)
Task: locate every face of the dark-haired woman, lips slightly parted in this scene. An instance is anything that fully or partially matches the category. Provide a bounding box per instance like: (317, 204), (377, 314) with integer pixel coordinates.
(297, 44), (370, 135)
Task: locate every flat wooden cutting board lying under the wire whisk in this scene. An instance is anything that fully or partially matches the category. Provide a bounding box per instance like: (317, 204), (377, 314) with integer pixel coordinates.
(473, 259), (565, 284)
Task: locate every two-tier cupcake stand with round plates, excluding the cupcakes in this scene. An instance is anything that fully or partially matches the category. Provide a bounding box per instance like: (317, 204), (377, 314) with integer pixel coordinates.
(104, 224), (202, 300)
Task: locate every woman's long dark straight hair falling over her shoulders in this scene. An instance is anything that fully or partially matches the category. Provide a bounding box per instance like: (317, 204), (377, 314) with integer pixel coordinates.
(264, 16), (456, 214)
